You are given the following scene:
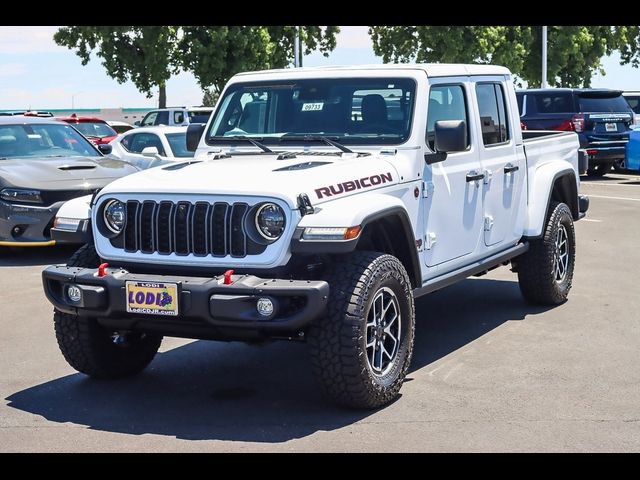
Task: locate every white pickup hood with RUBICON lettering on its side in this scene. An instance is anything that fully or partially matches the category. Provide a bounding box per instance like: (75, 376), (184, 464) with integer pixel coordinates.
(101, 154), (399, 208)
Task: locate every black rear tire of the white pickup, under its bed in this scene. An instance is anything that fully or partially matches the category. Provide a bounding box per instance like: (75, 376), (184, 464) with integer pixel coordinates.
(517, 201), (576, 305)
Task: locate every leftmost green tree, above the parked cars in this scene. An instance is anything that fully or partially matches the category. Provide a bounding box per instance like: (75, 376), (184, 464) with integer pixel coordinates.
(53, 26), (180, 108)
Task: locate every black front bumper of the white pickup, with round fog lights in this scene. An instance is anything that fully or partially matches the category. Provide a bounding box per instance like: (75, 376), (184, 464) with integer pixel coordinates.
(42, 265), (329, 338)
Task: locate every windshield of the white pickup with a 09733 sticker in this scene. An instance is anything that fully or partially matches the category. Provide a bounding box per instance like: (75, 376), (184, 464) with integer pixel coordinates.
(207, 78), (416, 144)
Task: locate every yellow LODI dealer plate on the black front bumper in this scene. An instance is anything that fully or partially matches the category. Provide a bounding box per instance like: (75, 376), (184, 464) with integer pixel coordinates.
(126, 282), (178, 316)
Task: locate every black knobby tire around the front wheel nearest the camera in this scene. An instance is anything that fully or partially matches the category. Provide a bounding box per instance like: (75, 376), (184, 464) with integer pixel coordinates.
(308, 252), (415, 408)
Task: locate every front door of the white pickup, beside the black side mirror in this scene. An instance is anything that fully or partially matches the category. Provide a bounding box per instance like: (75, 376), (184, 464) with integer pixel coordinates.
(423, 77), (482, 266)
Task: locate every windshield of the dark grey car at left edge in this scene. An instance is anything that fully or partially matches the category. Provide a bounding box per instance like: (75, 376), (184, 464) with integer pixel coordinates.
(0, 124), (101, 159)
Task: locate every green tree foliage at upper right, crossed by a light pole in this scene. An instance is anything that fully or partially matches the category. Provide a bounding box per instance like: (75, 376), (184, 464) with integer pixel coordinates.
(369, 26), (640, 87)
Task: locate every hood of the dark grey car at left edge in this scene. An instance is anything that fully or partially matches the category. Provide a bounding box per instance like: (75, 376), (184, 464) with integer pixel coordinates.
(0, 157), (138, 190)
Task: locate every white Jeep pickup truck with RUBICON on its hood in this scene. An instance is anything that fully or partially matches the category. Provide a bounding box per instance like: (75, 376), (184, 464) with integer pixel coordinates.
(43, 64), (588, 408)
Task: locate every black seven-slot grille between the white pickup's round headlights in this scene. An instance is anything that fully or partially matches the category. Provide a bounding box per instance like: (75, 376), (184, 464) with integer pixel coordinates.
(123, 200), (251, 257)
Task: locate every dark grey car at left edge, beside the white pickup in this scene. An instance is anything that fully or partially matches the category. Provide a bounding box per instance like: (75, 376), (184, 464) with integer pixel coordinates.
(0, 115), (139, 247)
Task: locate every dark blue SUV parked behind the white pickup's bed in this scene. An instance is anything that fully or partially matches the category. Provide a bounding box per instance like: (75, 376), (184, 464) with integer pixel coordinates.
(516, 88), (634, 176)
